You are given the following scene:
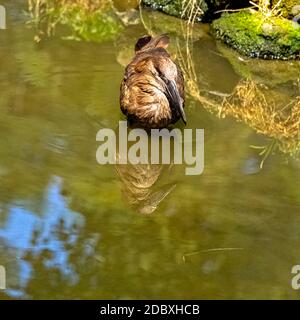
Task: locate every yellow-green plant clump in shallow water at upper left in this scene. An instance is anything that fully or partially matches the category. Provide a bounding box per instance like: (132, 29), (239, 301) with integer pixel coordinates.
(28, 0), (123, 42)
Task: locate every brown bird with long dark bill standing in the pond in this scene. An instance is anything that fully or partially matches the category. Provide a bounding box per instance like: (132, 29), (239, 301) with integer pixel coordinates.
(120, 35), (186, 128)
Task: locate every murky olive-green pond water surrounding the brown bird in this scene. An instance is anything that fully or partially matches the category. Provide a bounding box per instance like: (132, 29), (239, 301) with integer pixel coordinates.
(0, 1), (300, 299)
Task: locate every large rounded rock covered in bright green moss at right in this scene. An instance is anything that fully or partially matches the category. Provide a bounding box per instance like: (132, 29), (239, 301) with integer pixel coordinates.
(212, 11), (300, 60)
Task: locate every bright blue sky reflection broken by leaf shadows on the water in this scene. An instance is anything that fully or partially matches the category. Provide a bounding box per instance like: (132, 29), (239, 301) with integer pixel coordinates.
(0, 177), (85, 297)
